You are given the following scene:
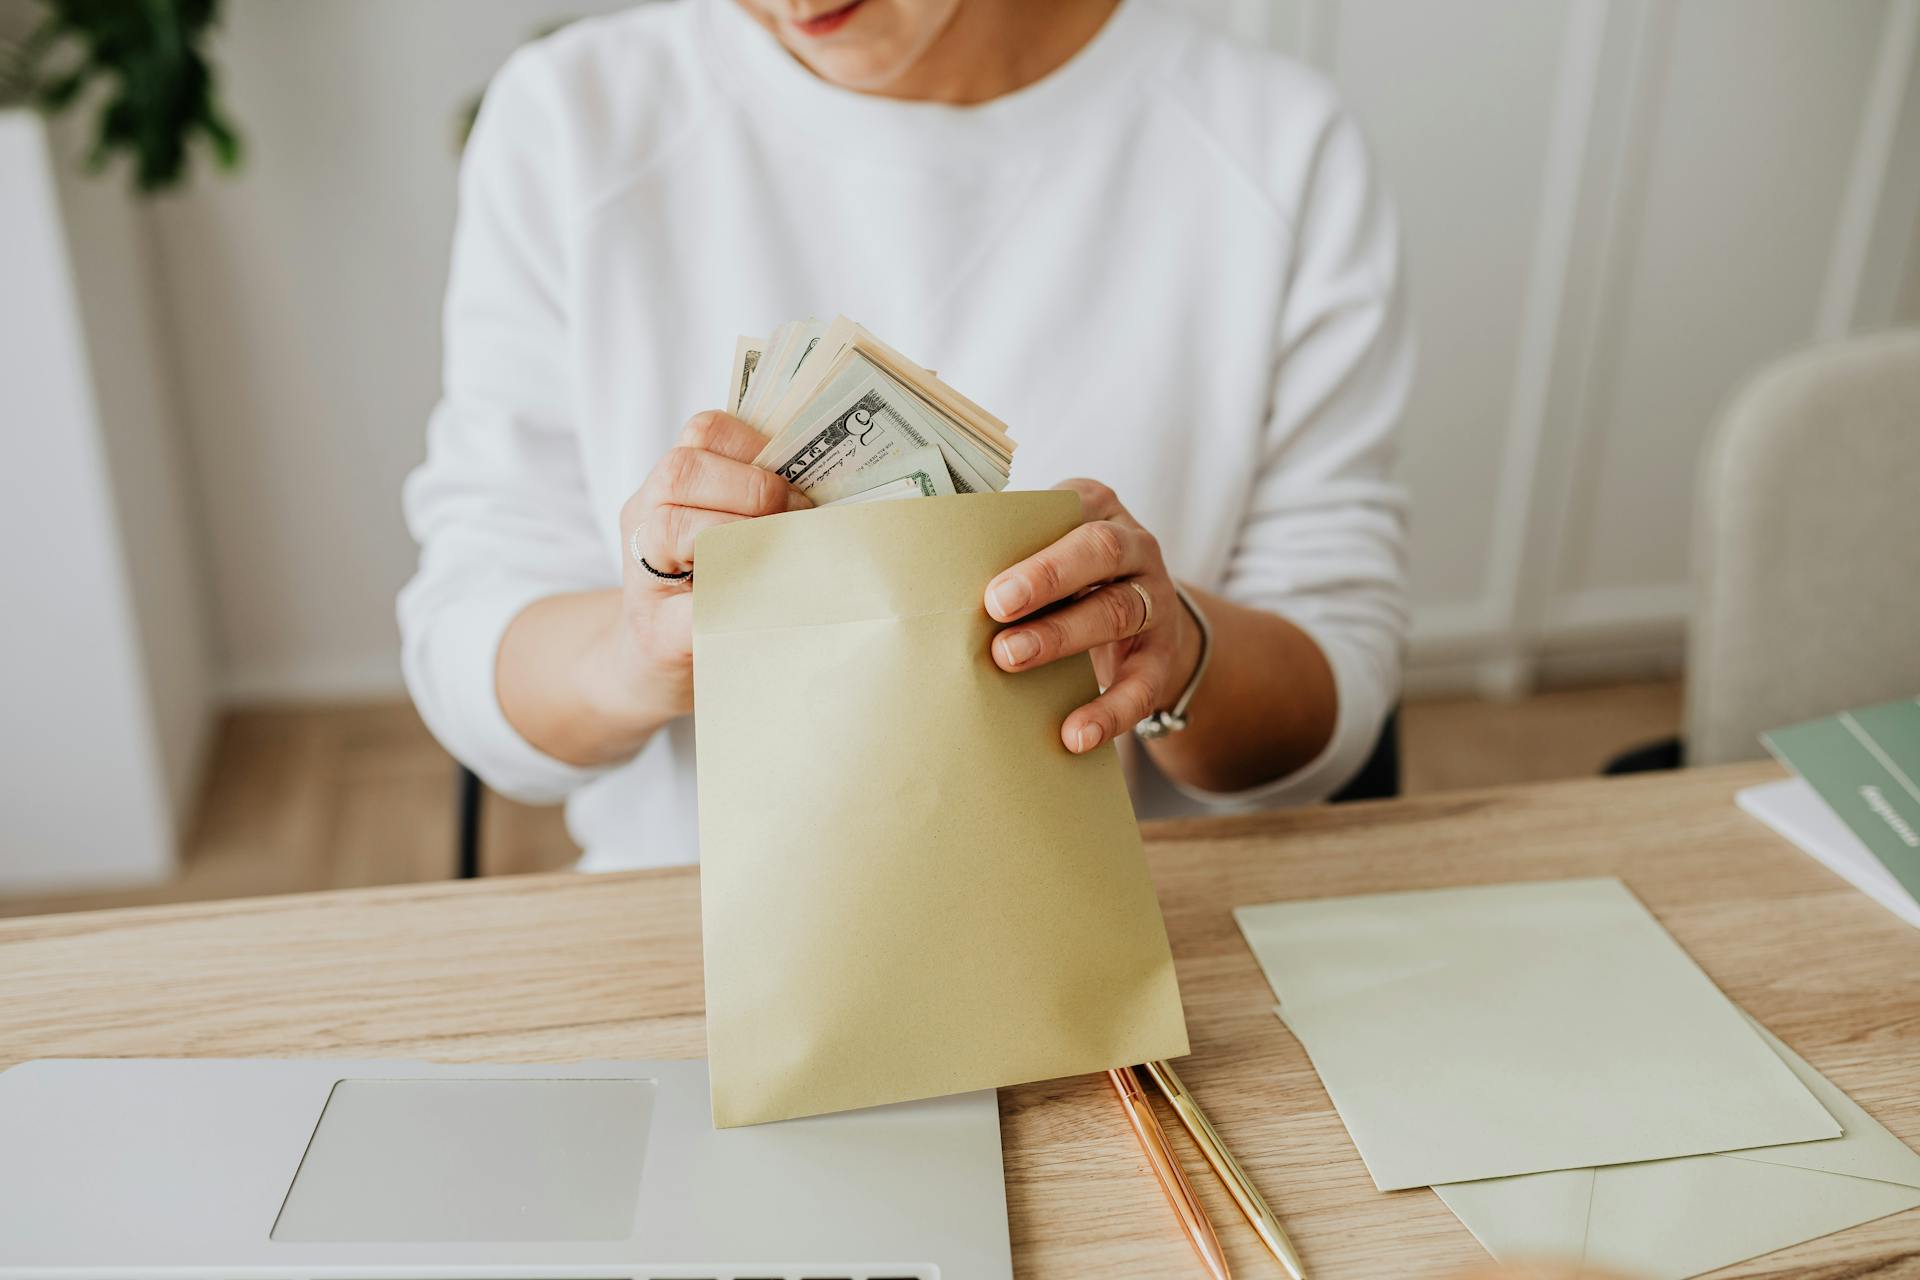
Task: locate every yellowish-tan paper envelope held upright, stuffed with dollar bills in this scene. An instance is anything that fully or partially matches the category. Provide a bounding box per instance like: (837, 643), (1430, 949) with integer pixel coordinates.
(693, 491), (1187, 1126)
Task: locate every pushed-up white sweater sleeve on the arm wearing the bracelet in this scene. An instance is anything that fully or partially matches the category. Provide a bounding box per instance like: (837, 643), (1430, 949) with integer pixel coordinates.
(1183, 115), (1413, 804)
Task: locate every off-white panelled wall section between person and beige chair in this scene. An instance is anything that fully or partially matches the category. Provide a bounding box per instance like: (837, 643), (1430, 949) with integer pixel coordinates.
(1196, 0), (1920, 693)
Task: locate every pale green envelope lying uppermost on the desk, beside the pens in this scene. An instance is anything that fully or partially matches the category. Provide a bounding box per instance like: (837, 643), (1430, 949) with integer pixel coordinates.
(1235, 879), (1839, 1192)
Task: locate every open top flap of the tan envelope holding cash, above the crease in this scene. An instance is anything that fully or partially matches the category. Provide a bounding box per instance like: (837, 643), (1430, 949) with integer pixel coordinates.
(693, 489), (1081, 635)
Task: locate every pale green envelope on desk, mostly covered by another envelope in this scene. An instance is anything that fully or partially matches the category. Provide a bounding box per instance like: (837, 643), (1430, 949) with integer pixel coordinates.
(1434, 1023), (1920, 1280)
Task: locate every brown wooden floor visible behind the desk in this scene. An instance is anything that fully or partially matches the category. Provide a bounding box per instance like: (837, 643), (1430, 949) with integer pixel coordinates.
(0, 683), (1680, 915)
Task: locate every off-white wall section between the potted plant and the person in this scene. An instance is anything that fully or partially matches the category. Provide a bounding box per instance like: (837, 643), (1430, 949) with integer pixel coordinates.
(156, 0), (620, 697)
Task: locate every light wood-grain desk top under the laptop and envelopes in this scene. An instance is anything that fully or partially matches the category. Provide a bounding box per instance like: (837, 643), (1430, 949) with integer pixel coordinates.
(0, 764), (1920, 1280)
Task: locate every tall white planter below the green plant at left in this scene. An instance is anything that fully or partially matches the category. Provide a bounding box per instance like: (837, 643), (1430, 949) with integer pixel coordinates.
(0, 109), (209, 894)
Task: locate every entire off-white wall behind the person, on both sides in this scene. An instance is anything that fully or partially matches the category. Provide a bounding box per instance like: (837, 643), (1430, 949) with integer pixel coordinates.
(142, 0), (1920, 697)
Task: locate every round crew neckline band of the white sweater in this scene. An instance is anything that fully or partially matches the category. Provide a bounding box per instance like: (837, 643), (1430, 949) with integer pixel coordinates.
(699, 0), (1154, 161)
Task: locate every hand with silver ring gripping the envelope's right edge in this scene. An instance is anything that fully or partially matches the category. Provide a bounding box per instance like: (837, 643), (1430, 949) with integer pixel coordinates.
(987, 480), (1200, 754)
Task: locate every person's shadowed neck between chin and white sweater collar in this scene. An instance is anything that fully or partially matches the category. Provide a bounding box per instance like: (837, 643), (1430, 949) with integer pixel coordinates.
(866, 0), (1119, 106)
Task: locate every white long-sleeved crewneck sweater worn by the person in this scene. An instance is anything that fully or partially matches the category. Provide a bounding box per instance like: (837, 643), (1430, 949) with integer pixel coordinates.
(399, 0), (1413, 869)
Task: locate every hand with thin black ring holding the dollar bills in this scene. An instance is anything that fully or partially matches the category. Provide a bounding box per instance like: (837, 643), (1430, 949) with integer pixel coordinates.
(614, 409), (812, 718)
